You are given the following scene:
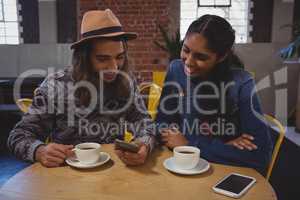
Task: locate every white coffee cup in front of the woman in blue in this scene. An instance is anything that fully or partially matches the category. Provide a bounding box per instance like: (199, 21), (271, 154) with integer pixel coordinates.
(173, 146), (200, 169)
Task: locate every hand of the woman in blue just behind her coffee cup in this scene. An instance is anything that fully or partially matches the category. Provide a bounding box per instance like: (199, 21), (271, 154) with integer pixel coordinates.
(161, 129), (188, 149)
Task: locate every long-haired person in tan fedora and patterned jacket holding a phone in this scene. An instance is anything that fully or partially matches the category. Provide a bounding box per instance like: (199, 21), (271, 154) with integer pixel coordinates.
(8, 9), (154, 167)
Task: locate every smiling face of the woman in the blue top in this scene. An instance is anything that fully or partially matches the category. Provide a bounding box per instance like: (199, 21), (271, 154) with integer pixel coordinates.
(181, 33), (219, 77)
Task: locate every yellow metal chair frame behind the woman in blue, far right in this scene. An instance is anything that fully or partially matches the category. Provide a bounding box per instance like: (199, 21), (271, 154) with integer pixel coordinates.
(264, 114), (285, 180)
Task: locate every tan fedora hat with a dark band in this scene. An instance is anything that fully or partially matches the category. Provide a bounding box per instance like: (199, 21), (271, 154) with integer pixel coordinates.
(71, 9), (137, 49)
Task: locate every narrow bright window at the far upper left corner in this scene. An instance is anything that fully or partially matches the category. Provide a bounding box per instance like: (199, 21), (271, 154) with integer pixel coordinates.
(0, 0), (20, 44)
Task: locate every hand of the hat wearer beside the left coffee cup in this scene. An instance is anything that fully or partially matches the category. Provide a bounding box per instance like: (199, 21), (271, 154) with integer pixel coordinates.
(35, 143), (74, 167)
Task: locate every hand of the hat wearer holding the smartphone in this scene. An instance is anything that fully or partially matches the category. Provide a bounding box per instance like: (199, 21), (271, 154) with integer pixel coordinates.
(115, 144), (149, 166)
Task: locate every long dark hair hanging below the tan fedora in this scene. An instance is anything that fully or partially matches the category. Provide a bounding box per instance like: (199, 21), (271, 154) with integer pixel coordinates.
(72, 37), (132, 106)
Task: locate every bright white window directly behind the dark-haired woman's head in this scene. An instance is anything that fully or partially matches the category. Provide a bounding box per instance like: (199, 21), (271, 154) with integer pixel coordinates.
(180, 0), (251, 43)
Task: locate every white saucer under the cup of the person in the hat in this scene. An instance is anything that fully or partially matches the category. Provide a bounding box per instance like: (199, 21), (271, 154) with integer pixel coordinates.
(66, 152), (110, 169)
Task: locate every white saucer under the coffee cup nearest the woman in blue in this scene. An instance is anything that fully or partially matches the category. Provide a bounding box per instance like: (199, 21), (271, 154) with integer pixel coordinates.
(164, 157), (210, 175)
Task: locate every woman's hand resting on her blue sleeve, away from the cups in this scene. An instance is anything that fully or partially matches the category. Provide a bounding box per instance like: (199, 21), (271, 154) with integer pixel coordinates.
(226, 133), (257, 151)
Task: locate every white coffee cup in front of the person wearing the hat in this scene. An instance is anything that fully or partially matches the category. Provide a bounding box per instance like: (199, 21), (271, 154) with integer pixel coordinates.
(72, 142), (101, 164)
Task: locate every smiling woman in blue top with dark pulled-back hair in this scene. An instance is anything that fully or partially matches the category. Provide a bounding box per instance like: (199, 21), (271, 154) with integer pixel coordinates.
(156, 15), (271, 173)
